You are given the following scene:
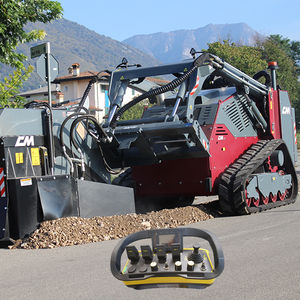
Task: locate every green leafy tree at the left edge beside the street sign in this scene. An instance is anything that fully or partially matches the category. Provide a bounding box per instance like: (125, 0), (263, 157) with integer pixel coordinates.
(0, 0), (62, 107)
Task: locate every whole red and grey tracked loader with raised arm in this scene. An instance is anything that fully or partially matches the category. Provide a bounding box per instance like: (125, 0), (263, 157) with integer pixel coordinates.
(101, 50), (298, 214)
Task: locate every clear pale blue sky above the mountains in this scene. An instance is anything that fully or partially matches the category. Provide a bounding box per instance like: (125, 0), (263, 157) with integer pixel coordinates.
(57, 0), (300, 41)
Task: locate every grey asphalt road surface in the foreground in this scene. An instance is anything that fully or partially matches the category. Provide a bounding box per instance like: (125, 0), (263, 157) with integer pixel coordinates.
(0, 199), (300, 300)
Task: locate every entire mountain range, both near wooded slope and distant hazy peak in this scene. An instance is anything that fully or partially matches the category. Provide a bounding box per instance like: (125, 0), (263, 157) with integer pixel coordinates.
(0, 19), (258, 91)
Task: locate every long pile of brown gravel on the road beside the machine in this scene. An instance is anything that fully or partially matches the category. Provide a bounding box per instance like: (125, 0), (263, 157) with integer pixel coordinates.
(9, 205), (213, 249)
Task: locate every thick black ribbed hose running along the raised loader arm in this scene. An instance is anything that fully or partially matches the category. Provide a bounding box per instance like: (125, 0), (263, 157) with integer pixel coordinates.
(110, 53), (210, 129)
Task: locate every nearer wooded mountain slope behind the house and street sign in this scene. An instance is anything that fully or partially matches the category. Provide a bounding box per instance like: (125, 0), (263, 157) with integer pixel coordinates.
(0, 19), (160, 91)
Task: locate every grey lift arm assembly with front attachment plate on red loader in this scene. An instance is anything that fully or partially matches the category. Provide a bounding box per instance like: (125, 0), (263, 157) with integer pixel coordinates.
(102, 53), (268, 167)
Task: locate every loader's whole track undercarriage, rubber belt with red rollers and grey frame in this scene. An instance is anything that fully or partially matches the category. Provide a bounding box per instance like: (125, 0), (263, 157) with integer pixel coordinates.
(219, 140), (298, 215)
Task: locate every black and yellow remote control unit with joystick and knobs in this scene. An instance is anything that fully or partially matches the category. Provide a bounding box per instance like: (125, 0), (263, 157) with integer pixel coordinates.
(111, 228), (224, 289)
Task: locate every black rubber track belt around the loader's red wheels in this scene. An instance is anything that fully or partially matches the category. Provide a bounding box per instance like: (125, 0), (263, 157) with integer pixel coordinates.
(219, 139), (298, 215)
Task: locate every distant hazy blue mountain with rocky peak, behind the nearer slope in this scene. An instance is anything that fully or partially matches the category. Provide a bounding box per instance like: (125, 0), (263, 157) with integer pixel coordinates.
(123, 23), (260, 63)
